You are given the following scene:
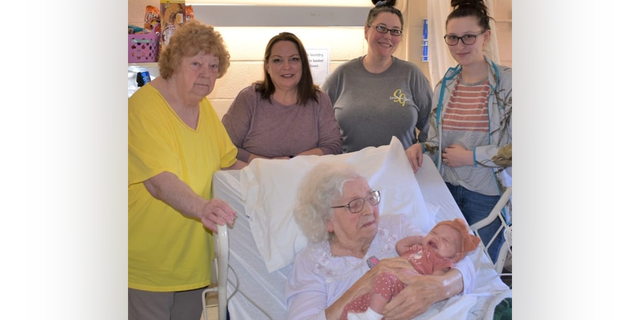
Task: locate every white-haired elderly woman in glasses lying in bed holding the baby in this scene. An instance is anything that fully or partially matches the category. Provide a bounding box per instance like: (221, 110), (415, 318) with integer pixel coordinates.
(285, 163), (475, 320)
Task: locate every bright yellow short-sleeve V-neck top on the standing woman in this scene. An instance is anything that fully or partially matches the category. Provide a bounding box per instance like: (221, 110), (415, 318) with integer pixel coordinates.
(128, 84), (238, 292)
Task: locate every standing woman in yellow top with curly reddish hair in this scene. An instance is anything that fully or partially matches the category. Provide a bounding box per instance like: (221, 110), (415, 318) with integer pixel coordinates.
(128, 20), (246, 320)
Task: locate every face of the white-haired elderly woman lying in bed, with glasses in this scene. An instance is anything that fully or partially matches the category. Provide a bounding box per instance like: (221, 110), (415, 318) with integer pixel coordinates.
(325, 178), (379, 258)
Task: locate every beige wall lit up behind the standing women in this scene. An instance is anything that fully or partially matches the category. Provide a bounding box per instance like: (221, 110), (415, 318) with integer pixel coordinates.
(128, 0), (512, 117)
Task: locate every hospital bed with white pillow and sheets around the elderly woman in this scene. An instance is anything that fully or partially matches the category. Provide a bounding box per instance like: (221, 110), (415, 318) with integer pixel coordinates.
(202, 138), (511, 320)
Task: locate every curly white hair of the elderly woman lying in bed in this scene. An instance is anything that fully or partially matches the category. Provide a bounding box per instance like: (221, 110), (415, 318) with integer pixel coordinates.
(293, 162), (364, 243)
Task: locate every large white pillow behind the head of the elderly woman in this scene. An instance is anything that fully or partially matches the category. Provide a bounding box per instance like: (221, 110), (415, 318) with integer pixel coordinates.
(240, 137), (436, 272)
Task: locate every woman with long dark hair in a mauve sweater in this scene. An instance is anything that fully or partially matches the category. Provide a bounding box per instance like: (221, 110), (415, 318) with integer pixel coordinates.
(222, 32), (342, 163)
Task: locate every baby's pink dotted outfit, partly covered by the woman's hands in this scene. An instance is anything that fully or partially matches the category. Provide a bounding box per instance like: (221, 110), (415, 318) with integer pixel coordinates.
(340, 244), (455, 320)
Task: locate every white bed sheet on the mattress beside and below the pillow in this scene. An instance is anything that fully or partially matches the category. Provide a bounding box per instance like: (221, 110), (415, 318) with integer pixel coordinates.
(213, 157), (511, 320)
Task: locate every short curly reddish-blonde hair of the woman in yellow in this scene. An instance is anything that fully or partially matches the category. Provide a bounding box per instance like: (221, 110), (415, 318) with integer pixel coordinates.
(158, 19), (230, 79)
